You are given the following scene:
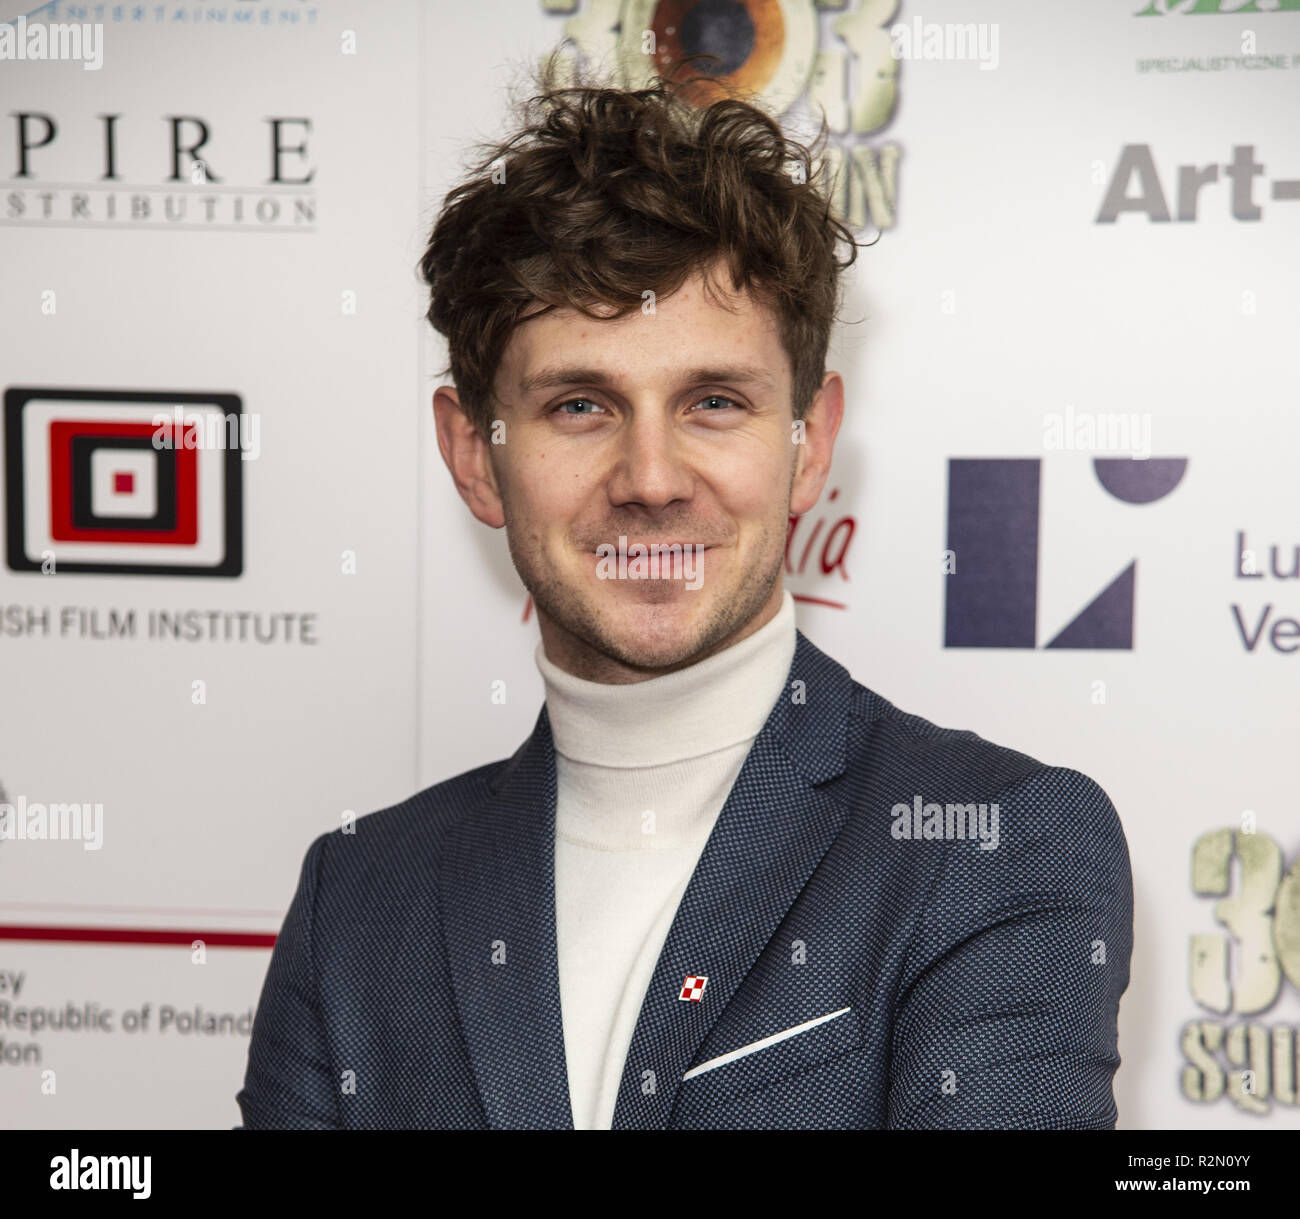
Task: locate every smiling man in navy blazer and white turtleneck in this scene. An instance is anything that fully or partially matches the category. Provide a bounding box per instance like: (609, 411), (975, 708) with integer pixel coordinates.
(239, 78), (1132, 1129)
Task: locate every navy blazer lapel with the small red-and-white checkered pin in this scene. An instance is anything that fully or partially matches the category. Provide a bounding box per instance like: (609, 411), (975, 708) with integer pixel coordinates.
(612, 632), (853, 1129)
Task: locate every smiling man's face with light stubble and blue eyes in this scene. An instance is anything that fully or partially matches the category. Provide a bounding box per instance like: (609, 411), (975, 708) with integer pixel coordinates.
(445, 259), (842, 681)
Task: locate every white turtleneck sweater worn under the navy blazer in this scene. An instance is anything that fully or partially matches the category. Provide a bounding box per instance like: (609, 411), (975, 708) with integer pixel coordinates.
(536, 591), (796, 1129)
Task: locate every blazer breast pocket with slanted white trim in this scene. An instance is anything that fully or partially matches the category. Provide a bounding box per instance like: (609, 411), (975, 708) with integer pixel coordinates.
(677, 1007), (862, 1107)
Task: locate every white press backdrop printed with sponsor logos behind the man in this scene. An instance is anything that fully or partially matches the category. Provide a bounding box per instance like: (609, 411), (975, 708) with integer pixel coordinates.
(0, 0), (1300, 1128)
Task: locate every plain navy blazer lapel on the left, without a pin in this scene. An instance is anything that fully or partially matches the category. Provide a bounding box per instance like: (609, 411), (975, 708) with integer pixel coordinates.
(441, 706), (573, 1129)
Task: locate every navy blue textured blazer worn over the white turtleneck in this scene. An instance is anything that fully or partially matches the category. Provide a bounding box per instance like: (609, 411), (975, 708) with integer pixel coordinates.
(238, 632), (1132, 1129)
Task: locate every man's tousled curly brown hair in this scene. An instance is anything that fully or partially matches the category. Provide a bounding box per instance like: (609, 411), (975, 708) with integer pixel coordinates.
(420, 68), (857, 434)
